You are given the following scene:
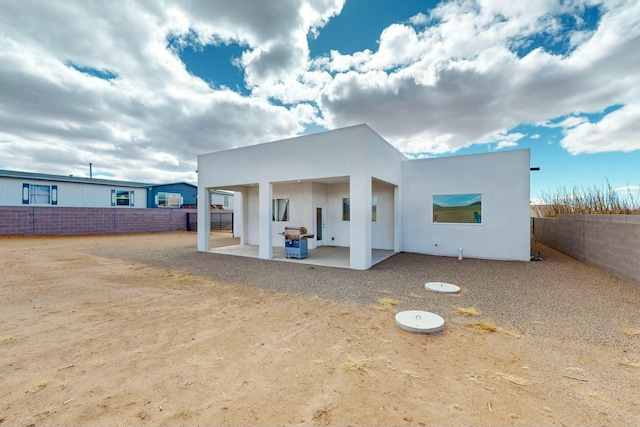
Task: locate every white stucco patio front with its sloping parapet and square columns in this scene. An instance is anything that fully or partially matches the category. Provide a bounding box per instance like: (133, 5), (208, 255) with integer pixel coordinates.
(198, 125), (406, 269)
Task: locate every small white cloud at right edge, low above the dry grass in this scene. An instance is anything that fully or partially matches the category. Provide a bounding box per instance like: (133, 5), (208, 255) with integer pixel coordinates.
(560, 104), (640, 154)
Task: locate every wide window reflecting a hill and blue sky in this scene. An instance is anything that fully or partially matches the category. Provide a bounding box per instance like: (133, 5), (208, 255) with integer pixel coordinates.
(433, 194), (482, 224)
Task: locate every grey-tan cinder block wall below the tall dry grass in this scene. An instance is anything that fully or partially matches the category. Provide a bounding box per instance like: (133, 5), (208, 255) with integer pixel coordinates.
(533, 215), (640, 286)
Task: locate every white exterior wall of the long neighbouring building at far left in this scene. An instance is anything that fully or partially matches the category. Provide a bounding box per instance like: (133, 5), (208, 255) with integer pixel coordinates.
(0, 177), (147, 209)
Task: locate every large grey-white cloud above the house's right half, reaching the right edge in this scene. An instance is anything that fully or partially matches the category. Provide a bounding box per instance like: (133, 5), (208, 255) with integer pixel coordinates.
(319, 0), (640, 153)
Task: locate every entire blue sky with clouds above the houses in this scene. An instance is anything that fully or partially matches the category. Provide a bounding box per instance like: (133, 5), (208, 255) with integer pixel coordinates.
(0, 0), (640, 198)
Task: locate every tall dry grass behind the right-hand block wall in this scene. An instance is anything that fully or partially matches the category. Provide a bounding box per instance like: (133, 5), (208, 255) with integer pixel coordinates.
(536, 181), (640, 218)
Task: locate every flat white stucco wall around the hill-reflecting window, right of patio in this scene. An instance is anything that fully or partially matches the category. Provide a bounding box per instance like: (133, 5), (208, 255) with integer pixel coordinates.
(401, 150), (530, 261)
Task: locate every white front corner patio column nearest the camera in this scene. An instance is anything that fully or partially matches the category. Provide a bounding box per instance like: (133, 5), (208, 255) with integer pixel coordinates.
(349, 173), (372, 270)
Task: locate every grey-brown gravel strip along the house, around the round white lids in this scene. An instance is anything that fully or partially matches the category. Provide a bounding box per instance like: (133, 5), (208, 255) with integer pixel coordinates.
(86, 233), (640, 350)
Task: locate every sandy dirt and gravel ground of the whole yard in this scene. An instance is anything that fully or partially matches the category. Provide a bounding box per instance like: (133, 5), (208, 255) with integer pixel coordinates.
(0, 233), (640, 426)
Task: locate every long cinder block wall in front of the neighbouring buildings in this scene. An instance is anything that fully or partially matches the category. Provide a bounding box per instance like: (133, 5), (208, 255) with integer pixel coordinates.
(0, 206), (196, 235)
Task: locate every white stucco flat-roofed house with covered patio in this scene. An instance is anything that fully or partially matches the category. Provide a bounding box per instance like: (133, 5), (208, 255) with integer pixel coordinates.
(198, 125), (530, 270)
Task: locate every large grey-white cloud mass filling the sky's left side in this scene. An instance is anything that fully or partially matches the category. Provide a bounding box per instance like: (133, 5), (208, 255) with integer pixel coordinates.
(0, 0), (343, 181)
